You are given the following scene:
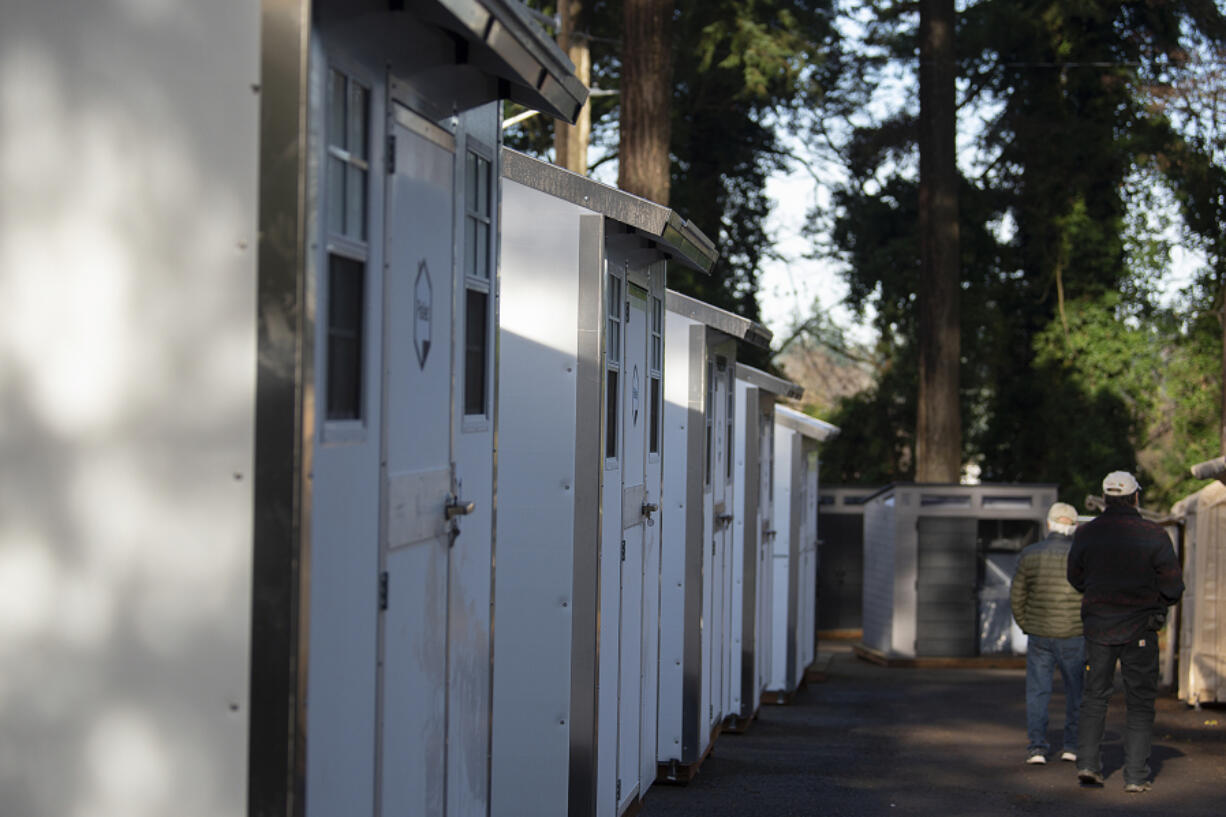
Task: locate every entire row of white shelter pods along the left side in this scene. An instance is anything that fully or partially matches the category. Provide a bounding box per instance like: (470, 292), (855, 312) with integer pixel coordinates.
(0, 0), (836, 817)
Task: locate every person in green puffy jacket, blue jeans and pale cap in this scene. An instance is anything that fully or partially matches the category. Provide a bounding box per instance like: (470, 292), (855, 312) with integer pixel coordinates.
(1009, 502), (1085, 764)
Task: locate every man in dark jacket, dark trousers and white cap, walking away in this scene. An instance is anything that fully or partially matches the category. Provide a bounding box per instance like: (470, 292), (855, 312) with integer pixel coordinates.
(1068, 471), (1183, 792)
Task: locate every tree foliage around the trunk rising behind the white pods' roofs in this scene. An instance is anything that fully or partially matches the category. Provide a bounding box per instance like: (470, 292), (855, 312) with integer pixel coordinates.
(505, 0), (839, 368)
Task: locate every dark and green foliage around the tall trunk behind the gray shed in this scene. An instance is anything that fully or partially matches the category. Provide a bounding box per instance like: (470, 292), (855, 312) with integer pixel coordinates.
(824, 0), (1226, 507)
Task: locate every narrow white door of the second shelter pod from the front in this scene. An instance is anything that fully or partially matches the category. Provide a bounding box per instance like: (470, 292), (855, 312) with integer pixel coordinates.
(615, 281), (650, 815)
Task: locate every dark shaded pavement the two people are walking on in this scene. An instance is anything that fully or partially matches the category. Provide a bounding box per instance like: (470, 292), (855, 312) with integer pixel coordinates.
(641, 644), (1226, 817)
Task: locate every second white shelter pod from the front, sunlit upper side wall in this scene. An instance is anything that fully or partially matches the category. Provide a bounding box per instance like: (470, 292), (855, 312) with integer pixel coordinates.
(490, 150), (716, 817)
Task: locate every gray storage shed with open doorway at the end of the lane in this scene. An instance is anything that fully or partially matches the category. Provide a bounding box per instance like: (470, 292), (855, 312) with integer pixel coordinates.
(863, 483), (1056, 658)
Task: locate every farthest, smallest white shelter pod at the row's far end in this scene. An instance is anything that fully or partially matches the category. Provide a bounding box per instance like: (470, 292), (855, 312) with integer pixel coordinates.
(764, 406), (839, 703)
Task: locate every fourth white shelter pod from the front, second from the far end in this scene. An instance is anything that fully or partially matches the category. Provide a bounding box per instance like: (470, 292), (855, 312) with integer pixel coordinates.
(725, 363), (804, 731)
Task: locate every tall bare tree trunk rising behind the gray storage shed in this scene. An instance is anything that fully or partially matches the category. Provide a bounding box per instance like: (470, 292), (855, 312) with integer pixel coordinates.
(916, 0), (962, 482)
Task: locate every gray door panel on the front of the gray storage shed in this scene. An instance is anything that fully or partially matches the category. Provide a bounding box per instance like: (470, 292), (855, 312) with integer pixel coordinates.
(916, 516), (978, 658)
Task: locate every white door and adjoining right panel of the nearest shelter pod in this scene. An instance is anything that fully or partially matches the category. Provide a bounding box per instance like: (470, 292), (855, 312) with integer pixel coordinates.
(378, 104), (493, 816)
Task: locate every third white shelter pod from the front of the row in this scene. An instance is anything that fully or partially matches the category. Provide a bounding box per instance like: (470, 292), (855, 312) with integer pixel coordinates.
(657, 291), (770, 780)
